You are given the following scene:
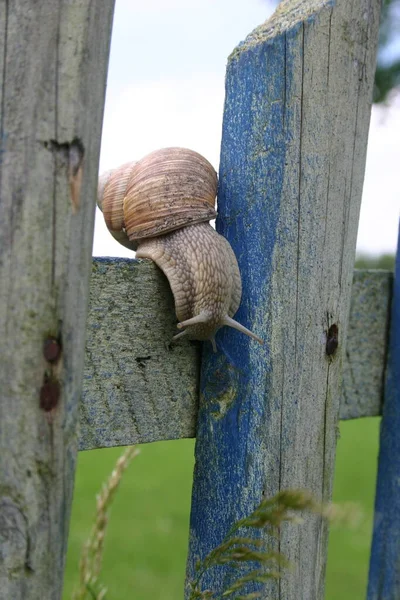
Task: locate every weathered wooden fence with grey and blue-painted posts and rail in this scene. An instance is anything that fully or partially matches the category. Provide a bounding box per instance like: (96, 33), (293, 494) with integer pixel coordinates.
(0, 0), (400, 600)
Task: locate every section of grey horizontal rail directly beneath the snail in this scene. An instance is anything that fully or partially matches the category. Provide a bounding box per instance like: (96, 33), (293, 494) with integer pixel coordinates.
(80, 259), (200, 450)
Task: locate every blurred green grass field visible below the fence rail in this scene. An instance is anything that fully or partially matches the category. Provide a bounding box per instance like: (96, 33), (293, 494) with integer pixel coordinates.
(63, 419), (379, 600)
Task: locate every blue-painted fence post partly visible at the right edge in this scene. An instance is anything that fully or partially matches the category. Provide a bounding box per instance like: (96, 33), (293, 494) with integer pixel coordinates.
(367, 229), (400, 600)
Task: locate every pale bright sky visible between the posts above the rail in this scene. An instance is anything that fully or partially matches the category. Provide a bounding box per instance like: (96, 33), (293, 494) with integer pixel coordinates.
(93, 0), (400, 256)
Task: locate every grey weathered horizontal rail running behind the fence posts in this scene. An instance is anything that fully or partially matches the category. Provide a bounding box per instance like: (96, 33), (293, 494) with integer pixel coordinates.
(79, 258), (392, 450)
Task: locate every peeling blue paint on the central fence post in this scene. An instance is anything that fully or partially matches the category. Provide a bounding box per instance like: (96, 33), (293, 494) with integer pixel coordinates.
(188, 26), (301, 597)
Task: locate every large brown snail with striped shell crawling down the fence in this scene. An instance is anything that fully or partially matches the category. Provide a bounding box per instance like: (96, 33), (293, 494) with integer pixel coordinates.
(97, 148), (262, 352)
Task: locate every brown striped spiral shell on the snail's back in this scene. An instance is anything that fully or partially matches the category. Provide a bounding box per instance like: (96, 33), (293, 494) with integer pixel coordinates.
(98, 148), (218, 249)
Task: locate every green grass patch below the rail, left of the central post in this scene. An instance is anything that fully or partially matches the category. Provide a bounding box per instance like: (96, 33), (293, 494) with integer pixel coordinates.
(63, 440), (194, 600)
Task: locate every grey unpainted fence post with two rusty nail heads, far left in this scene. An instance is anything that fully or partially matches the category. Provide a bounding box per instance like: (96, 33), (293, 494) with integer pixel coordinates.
(0, 0), (113, 600)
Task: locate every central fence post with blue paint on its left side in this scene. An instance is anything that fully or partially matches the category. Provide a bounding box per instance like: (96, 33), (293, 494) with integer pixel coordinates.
(186, 0), (380, 600)
